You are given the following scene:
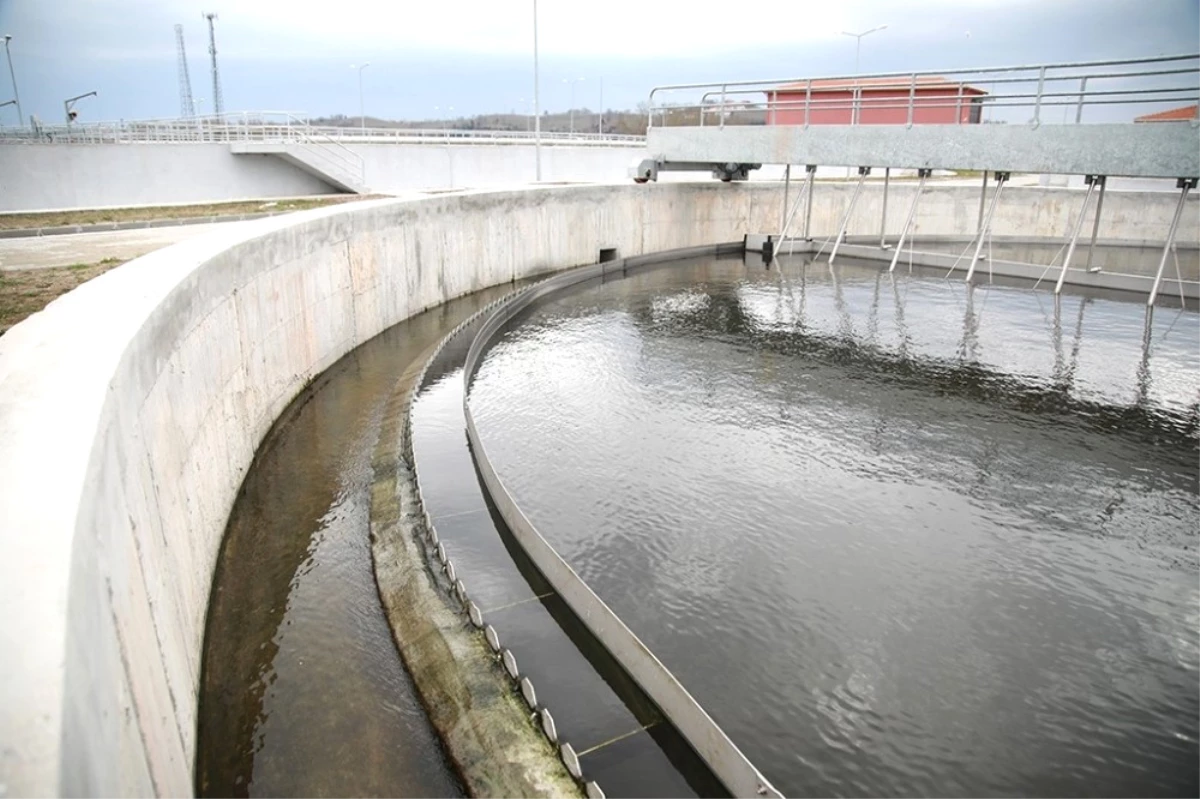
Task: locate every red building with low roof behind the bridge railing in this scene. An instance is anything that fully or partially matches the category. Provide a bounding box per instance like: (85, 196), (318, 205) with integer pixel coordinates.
(767, 76), (988, 125)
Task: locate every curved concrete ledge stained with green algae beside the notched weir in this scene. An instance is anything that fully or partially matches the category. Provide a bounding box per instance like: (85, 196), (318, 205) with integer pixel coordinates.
(371, 350), (582, 797)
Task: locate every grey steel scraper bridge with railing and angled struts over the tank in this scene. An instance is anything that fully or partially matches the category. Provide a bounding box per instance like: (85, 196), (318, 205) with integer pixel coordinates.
(631, 54), (1200, 306)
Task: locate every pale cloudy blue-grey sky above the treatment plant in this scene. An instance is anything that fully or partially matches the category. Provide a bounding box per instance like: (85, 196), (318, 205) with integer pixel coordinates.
(0, 0), (1200, 125)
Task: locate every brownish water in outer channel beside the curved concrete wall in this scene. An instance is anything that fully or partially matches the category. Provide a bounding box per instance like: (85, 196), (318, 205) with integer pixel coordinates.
(197, 288), (516, 797)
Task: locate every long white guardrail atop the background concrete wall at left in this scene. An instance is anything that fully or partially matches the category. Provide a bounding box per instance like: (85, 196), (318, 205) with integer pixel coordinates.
(0, 112), (646, 146)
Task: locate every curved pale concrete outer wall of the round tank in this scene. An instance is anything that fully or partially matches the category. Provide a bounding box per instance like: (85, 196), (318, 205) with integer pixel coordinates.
(0, 184), (1200, 797)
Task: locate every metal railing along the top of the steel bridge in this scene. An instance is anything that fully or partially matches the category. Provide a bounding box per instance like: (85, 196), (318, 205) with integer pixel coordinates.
(648, 54), (1200, 127)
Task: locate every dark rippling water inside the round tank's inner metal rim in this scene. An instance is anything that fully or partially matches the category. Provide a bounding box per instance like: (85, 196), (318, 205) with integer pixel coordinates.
(472, 259), (1200, 795)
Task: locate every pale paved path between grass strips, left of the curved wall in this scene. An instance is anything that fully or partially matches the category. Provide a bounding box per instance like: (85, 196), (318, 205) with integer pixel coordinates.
(0, 222), (247, 271)
